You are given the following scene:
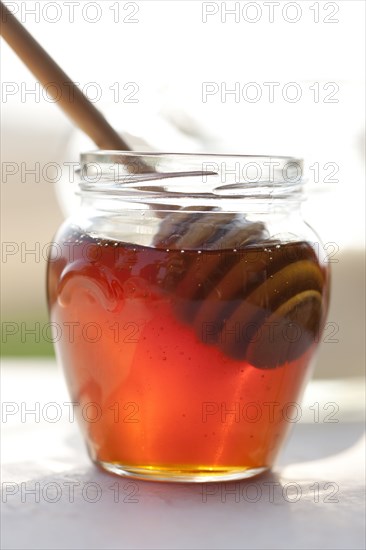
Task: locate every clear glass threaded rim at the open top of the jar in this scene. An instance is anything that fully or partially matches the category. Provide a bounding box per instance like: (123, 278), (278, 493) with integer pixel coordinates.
(79, 150), (304, 203)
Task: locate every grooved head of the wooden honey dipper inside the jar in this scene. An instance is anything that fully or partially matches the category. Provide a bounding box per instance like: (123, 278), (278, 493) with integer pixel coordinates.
(154, 212), (325, 369)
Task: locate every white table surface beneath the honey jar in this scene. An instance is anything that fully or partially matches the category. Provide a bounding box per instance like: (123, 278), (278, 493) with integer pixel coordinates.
(2, 360), (365, 550)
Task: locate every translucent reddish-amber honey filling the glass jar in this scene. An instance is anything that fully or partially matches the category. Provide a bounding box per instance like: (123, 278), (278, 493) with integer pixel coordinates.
(48, 224), (327, 480)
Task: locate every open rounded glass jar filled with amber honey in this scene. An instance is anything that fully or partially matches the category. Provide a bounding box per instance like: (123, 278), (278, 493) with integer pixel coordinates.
(48, 151), (329, 481)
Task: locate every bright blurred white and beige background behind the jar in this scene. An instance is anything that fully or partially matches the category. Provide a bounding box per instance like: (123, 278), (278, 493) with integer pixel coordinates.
(1, 0), (365, 376)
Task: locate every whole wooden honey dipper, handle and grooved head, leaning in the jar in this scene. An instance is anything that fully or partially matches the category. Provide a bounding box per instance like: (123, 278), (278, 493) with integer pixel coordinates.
(0, 2), (325, 368)
